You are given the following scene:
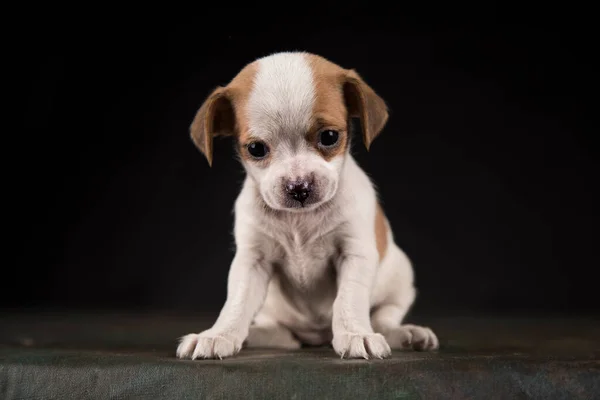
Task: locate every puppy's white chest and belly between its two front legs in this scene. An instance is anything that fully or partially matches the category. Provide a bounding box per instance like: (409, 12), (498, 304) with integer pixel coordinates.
(252, 211), (343, 336)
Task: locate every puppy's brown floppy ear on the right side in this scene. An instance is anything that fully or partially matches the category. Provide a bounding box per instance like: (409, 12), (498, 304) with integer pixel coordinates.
(343, 70), (388, 150)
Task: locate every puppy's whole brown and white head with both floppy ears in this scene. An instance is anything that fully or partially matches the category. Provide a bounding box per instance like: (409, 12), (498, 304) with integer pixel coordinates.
(191, 53), (388, 211)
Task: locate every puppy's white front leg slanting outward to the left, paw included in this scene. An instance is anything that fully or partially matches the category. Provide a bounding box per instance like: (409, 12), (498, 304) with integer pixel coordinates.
(177, 250), (271, 360)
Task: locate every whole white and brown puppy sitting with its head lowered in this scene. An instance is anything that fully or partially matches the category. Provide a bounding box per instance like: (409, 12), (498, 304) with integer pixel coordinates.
(177, 52), (438, 359)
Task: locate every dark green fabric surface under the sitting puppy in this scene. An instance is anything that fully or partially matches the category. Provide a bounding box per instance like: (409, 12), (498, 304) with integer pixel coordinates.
(0, 314), (600, 399)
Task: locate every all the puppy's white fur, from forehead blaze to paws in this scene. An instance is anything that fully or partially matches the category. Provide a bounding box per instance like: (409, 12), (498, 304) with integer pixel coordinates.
(177, 53), (438, 359)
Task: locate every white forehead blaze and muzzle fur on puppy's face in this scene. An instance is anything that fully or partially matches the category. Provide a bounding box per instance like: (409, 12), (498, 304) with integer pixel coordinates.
(245, 53), (341, 210)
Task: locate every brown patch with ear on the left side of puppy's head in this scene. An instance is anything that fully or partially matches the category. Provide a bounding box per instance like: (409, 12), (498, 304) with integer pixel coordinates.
(190, 62), (257, 165)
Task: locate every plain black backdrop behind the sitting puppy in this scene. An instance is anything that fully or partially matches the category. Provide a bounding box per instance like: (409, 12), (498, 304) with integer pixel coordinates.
(8, 2), (600, 313)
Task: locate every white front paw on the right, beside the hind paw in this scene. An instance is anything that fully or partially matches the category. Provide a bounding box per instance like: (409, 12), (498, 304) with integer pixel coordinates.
(331, 332), (392, 359)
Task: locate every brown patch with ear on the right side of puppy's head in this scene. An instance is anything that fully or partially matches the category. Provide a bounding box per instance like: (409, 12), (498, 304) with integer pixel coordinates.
(306, 54), (388, 155)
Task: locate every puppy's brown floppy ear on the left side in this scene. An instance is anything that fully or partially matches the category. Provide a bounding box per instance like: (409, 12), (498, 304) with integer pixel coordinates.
(190, 87), (235, 166)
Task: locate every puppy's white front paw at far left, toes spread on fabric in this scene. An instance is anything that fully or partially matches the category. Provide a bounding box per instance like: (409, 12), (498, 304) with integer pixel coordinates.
(177, 331), (241, 360)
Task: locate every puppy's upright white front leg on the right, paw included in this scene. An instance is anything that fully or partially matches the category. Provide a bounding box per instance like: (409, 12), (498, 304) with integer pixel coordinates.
(332, 248), (391, 359)
